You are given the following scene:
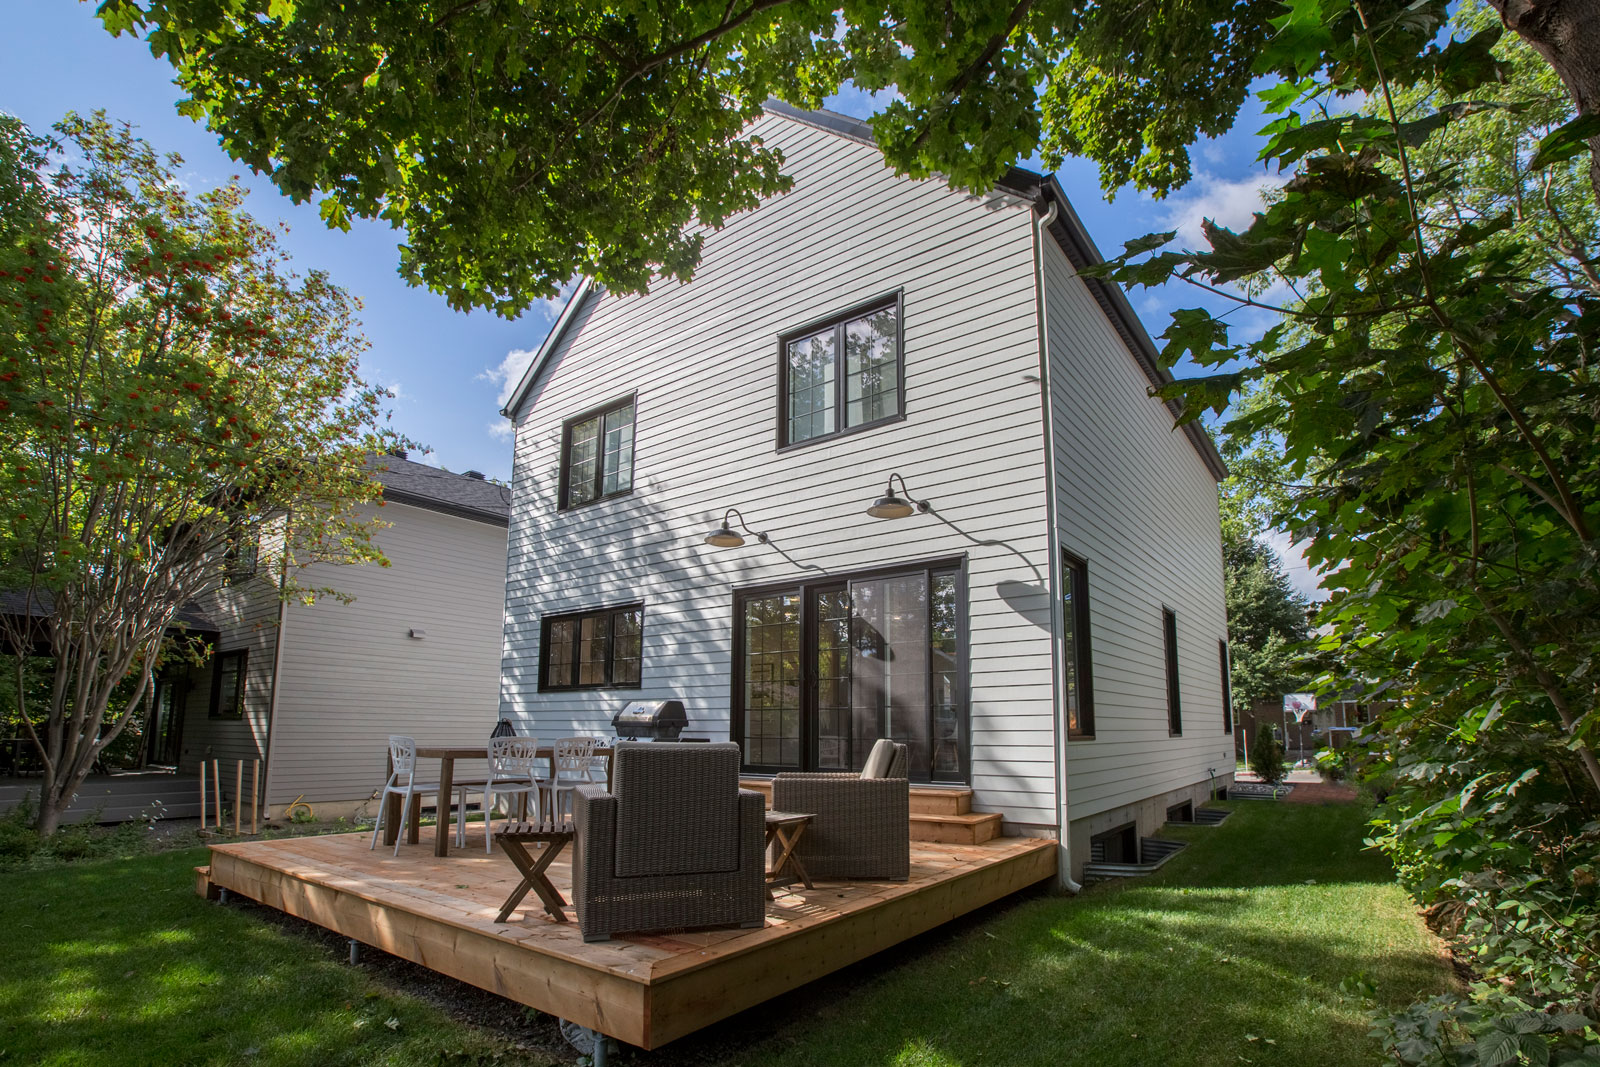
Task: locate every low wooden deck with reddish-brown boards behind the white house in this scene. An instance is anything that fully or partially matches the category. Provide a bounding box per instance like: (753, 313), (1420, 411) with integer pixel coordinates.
(198, 833), (1056, 1048)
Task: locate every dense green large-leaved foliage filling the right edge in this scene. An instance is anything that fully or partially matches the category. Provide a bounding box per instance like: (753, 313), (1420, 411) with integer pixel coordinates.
(1088, 0), (1600, 1064)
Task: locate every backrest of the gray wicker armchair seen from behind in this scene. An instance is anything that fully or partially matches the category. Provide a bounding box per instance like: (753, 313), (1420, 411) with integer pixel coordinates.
(611, 741), (739, 878)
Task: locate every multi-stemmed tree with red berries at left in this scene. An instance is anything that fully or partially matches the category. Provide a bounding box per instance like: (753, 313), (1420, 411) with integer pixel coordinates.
(0, 115), (393, 833)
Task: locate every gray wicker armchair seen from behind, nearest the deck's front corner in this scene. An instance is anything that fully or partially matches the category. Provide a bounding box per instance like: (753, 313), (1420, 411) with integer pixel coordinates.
(573, 741), (766, 941)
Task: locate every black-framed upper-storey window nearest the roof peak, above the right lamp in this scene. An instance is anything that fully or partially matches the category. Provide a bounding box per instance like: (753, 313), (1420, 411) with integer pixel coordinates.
(778, 296), (904, 448)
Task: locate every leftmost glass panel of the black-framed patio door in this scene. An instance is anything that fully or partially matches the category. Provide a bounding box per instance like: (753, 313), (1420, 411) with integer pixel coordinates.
(741, 592), (800, 769)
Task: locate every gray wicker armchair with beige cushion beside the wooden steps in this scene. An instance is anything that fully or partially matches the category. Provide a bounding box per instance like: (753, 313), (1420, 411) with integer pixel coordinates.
(773, 741), (910, 881)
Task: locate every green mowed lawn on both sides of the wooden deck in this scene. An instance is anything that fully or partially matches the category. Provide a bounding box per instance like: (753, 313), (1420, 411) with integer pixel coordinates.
(0, 803), (1450, 1067)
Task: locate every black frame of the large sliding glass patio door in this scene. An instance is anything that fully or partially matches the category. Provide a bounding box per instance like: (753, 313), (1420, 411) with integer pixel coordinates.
(728, 555), (973, 784)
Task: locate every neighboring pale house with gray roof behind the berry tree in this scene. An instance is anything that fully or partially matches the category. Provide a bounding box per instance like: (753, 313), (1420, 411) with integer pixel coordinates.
(147, 454), (509, 816)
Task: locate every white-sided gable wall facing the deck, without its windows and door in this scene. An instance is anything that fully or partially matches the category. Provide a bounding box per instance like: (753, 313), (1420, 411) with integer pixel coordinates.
(501, 115), (1056, 825)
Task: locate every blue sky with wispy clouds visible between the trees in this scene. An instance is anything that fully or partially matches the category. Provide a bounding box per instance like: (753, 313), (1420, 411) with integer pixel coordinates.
(0, 0), (1301, 591)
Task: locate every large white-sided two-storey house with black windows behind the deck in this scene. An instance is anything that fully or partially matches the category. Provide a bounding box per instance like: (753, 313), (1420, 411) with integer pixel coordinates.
(501, 104), (1234, 873)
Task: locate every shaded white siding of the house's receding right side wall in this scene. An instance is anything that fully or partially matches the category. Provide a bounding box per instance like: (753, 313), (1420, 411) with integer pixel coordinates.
(1045, 242), (1234, 821)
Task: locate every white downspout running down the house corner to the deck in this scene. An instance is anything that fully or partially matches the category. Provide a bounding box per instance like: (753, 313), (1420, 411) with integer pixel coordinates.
(1034, 200), (1083, 893)
